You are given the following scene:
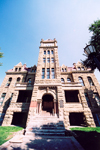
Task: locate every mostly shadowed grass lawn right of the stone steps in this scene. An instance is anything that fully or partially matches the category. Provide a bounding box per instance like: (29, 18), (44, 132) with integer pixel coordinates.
(70, 127), (100, 150)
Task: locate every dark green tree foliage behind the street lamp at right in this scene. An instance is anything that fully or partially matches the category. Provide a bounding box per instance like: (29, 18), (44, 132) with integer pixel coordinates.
(83, 20), (100, 70)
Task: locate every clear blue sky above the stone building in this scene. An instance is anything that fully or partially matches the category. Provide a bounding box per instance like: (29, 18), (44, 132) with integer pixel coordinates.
(0, 0), (100, 84)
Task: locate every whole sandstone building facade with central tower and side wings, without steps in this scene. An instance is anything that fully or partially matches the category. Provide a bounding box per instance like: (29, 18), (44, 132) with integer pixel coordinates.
(0, 39), (100, 128)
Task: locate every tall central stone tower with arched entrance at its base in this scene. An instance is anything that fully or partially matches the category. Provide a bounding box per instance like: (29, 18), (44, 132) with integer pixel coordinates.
(29, 39), (64, 118)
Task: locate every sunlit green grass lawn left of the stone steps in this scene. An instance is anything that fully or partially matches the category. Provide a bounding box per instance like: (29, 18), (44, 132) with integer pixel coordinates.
(0, 126), (23, 145)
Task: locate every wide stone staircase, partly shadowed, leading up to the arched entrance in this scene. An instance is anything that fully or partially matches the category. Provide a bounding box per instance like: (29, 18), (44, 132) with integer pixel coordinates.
(25, 111), (65, 136)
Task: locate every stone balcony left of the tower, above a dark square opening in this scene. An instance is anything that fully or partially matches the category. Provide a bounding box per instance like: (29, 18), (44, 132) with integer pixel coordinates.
(15, 82), (33, 90)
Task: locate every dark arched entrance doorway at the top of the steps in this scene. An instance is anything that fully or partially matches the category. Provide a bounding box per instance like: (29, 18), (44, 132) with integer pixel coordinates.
(42, 94), (54, 114)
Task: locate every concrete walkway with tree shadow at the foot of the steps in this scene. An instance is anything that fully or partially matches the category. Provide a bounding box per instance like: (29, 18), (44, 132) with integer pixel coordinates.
(0, 136), (84, 150)
